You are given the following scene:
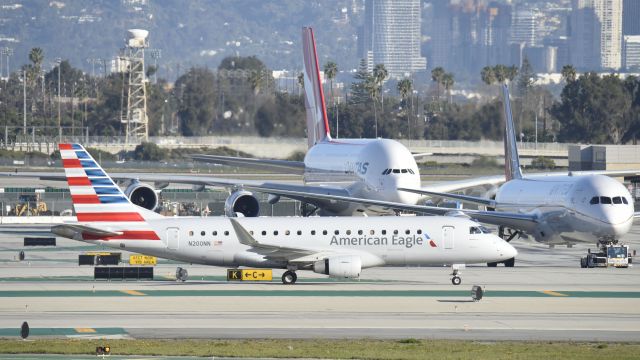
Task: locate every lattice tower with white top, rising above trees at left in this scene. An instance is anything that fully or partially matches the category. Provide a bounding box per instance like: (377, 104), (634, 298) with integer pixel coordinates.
(121, 29), (149, 144)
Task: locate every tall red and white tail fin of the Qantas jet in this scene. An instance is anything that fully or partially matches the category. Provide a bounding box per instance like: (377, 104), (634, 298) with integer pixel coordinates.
(302, 27), (331, 147)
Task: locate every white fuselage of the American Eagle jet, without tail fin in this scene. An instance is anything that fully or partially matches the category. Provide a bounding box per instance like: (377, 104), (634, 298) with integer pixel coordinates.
(88, 216), (517, 268)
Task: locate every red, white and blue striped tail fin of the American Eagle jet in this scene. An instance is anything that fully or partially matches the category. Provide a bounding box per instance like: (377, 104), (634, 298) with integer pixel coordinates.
(58, 144), (160, 240)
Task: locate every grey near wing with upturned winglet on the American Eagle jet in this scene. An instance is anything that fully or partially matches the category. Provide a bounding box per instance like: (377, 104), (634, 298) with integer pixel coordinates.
(229, 218), (330, 262)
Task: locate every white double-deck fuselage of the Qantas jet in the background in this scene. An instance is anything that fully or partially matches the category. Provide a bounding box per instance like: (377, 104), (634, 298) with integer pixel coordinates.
(304, 139), (420, 215)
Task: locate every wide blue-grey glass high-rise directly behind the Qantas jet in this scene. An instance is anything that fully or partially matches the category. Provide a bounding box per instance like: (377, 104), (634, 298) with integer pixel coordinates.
(362, 0), (427, 78)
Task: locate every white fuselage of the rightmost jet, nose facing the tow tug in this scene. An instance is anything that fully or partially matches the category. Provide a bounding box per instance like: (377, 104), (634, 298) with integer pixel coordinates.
(496, 175), (634, 243)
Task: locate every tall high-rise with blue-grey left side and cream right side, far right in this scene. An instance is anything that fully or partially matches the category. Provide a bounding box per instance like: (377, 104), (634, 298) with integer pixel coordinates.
(570, 0), (622, 70)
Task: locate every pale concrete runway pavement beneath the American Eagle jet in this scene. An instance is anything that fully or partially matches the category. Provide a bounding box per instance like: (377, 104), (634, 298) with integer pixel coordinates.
(0, 227), (640, 342)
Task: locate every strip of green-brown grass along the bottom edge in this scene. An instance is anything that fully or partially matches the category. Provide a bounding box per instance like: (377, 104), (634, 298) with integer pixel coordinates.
(0, 339), (640, 360)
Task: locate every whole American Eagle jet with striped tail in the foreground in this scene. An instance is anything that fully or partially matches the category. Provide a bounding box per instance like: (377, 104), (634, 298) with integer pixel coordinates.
(52, 144), (517, 285)
